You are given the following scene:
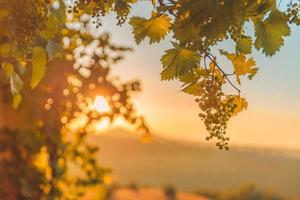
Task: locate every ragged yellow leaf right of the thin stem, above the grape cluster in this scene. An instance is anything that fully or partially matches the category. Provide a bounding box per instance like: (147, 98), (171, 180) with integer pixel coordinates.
(220, 50), (258, 84)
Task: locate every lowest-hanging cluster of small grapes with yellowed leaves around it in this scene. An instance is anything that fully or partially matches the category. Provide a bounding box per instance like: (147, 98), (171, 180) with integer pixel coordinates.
(181, 54), (247, 150)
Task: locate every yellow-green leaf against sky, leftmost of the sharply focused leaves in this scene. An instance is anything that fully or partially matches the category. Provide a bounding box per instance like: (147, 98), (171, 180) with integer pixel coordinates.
(129, 12), (171, 44)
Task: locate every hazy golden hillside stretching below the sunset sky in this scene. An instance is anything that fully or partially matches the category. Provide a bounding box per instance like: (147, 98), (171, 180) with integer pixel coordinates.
(90, 130), (300, 199)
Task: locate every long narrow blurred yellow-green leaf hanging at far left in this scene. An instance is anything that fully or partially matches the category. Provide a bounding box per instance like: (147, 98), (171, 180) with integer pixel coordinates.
(30, 47), (47, 89)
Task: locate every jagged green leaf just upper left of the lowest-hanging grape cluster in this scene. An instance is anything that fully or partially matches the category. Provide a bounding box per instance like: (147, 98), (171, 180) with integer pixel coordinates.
(160, 44), (201, 80)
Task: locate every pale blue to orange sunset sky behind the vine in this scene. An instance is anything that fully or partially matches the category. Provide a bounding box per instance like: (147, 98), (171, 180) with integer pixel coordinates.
(97, 2), (300, 149)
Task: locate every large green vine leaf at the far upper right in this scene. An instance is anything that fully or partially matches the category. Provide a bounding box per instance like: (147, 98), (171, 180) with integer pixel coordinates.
(254, 10), (290, 56)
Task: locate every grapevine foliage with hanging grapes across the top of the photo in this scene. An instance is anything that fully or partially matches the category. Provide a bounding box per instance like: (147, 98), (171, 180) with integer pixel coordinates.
(0, 0), (300, 149)
